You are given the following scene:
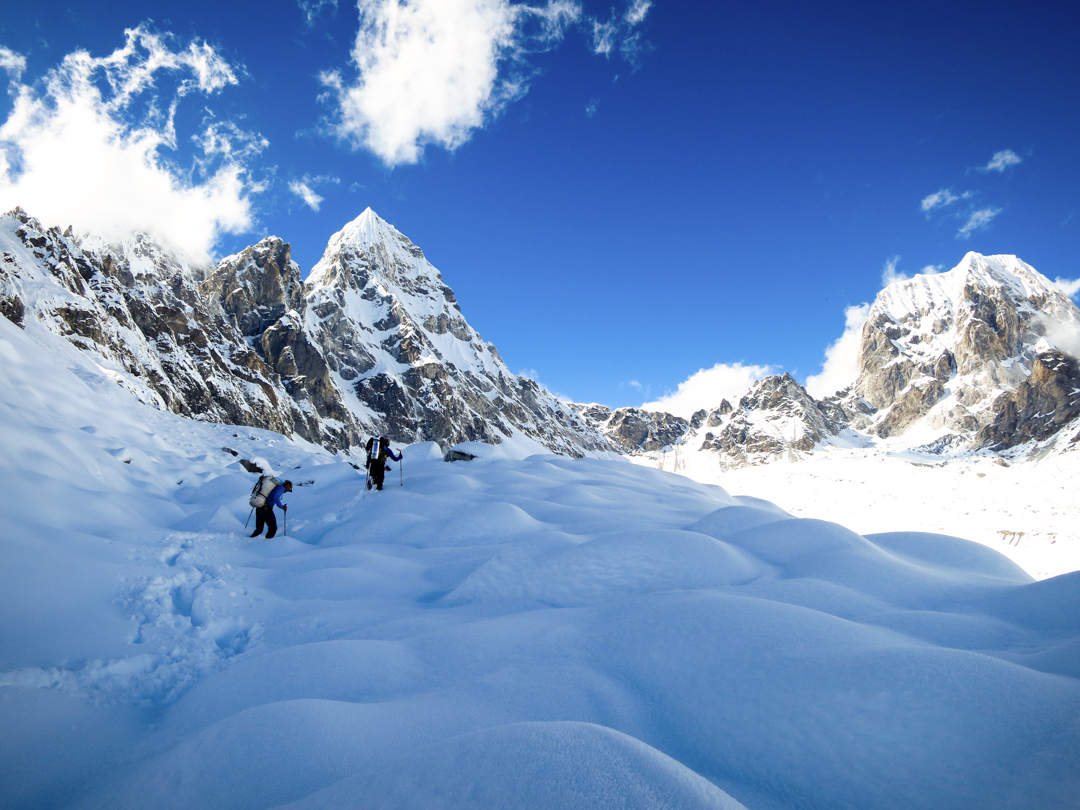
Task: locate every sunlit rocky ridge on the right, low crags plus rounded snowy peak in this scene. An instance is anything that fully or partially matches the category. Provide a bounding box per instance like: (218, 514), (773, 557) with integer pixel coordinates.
(577, 253), (1080, 467)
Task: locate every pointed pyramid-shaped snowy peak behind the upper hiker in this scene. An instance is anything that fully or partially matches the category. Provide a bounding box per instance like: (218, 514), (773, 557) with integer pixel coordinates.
(289, 210), (613, 455)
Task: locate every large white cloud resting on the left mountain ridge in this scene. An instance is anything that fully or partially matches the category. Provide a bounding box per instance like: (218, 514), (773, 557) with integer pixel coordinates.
(0, 27), (267, 258)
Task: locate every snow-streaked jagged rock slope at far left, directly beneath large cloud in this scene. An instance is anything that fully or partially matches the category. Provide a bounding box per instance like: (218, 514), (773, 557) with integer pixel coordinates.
(0, 210), (310, 434)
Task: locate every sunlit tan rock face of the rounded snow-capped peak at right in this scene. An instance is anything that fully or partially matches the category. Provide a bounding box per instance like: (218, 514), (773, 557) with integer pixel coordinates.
(849, 253), (1080, 440)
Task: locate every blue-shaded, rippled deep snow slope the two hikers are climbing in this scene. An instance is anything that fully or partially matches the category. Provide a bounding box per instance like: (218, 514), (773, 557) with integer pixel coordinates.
(0, 319), (1080, 810)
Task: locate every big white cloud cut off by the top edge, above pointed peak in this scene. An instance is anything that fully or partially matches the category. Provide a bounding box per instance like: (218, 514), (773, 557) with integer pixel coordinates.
(321, 0), (650, 166)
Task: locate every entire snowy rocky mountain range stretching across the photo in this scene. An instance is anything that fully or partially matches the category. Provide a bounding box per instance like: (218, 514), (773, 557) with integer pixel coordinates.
(0, 208), (1080, 469)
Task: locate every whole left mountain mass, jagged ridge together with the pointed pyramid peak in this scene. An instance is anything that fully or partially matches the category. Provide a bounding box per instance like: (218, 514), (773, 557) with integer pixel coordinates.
(0, 210), (613, 456)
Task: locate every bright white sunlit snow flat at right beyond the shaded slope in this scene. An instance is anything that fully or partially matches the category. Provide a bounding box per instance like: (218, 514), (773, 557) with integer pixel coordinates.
(666, 447), (1080, 579)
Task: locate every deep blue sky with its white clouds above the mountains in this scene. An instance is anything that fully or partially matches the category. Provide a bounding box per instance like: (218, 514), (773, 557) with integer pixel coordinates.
(0, 0), (1080, 406)
